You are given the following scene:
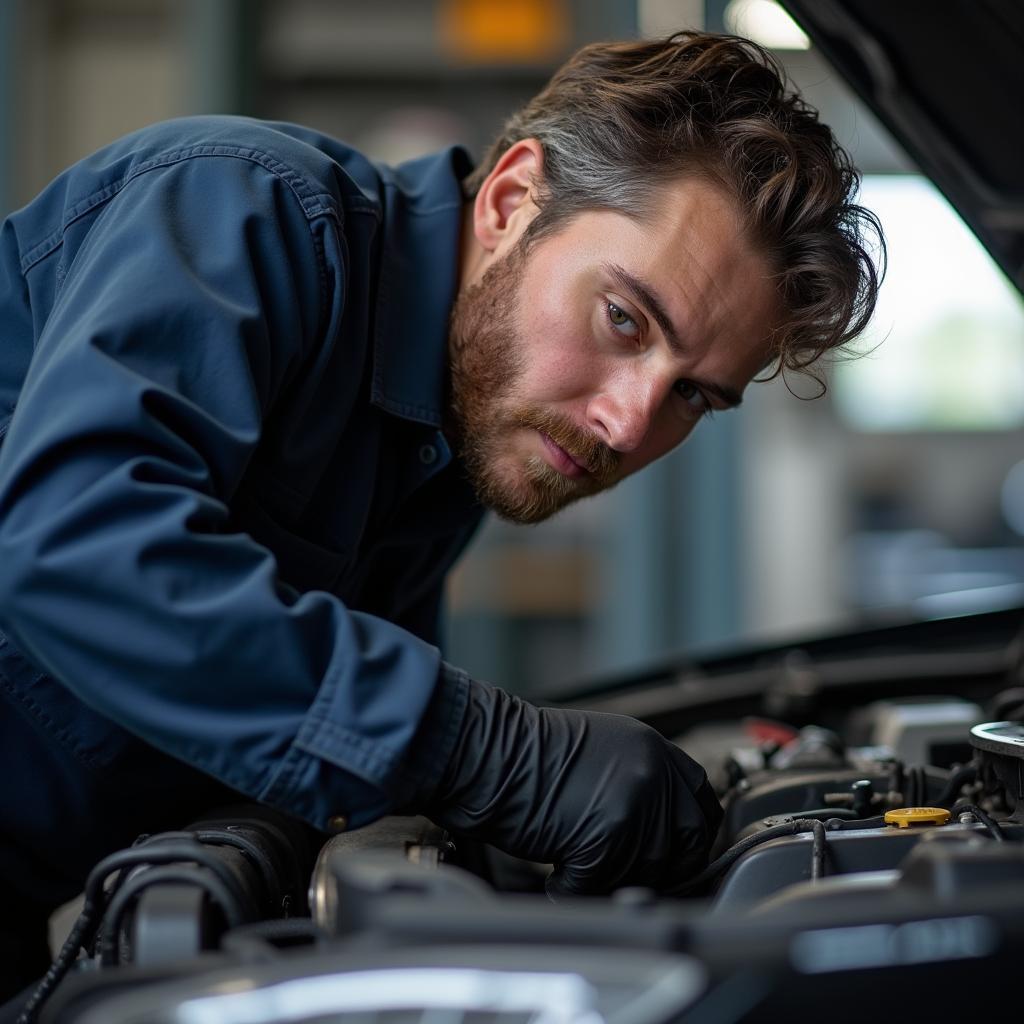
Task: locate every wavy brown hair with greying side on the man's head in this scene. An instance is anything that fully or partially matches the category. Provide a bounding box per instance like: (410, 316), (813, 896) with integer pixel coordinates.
(466, 32), (885, 376)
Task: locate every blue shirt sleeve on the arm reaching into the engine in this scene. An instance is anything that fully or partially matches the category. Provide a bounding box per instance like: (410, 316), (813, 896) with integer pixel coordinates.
(0, 151), (468, 827)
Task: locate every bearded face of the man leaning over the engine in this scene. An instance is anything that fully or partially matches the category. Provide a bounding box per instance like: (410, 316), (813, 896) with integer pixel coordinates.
(451, 179), (778, 522)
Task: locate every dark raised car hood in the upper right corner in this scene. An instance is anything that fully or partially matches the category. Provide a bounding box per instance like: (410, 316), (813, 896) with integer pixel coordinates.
(782, 0), (1024, 294)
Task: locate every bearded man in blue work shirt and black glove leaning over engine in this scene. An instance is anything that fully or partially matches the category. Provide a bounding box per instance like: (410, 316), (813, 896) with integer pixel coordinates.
(0, 33), (877, 995)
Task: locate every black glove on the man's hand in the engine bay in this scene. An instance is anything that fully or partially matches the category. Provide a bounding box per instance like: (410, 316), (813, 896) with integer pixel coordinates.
(427, 682), (722, 897)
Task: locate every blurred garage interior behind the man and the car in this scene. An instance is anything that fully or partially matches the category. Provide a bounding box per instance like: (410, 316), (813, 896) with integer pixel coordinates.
(0, 0), (1024, 696)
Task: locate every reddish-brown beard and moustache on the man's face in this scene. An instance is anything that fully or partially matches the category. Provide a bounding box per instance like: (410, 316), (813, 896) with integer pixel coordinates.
(449, 244), (620, 523)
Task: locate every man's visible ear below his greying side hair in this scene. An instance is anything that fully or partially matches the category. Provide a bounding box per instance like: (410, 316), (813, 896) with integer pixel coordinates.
(473, 138), (544, 254)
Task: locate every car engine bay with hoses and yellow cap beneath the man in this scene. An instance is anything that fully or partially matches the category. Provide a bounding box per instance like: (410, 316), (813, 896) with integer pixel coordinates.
(12, 616), (1024, 1024)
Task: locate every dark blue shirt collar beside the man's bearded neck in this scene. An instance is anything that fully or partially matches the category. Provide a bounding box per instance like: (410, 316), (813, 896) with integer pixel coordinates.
(371, 146), (472, 427)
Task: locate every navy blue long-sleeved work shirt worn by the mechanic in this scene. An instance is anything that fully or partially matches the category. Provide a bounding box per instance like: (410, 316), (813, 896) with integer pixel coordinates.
(0, 118), (481, 905)
